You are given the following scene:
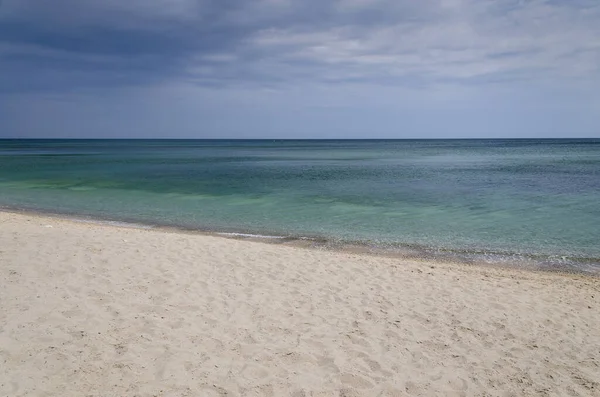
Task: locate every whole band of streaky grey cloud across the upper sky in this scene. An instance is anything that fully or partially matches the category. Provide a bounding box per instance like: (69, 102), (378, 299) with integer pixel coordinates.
(0, 0), (600, 92)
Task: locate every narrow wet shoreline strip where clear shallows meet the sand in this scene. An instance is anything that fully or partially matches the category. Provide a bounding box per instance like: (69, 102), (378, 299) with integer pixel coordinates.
(0, 206), (600, 277)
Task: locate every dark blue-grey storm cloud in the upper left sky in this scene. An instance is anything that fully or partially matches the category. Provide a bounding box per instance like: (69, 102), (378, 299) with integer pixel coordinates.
(0, 0), (247, 89)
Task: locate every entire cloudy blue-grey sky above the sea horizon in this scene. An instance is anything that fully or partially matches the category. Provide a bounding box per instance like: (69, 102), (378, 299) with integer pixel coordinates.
(0, 0), (600, 139)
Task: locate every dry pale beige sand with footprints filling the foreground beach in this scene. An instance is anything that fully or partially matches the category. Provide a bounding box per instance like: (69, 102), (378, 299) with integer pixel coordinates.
(0, 212), (600, 397)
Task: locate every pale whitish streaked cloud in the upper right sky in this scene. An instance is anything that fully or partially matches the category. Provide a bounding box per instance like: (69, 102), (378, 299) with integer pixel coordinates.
(246, 0), (600, 86)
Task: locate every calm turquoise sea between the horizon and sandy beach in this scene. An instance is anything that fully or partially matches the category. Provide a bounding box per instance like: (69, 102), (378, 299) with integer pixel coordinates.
(0, 140), (600, 271)
